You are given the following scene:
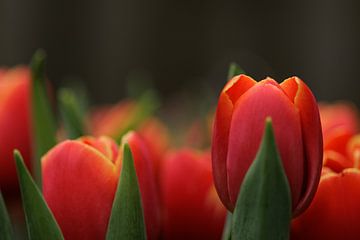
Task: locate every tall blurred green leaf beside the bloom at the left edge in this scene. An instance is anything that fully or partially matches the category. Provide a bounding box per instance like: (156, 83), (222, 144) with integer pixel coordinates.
(30, 50), (56, 189)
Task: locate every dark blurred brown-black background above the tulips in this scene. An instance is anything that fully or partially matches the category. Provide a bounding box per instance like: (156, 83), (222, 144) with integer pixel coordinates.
(0, 0), (360, 106)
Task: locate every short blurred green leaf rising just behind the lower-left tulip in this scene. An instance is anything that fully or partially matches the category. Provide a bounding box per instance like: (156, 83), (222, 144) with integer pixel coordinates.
(58, 88), (85, 139)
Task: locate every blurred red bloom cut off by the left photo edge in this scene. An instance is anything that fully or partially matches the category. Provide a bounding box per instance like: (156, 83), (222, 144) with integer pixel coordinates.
(0, 67), (31, 195)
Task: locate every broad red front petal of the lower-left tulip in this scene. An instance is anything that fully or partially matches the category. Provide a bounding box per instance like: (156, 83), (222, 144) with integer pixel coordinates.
(42, 140), (120, 239)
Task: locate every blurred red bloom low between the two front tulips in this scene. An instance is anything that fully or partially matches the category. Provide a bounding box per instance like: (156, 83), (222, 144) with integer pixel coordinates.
(161, 149), (226, 240)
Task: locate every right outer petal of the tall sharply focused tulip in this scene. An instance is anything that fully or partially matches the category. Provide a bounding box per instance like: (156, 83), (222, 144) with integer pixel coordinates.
(281, 77), (323, 216)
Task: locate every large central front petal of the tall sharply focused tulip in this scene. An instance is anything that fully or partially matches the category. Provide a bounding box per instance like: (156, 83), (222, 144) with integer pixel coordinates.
(227, 79), (304, 208)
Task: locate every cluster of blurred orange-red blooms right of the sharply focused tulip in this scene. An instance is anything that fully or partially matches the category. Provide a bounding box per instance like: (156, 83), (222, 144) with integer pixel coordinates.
(291, 104), (360, 240)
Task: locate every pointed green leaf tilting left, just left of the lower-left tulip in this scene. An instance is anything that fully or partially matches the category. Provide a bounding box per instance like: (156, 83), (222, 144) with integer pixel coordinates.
(14, 150), (64, 240)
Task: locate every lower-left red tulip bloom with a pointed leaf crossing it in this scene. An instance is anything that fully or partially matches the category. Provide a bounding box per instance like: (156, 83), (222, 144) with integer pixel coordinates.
(42, 132), (160, 239)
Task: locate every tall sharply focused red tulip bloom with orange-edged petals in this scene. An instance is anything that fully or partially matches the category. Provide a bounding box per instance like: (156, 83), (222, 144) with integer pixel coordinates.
(212, 75), (322, 216)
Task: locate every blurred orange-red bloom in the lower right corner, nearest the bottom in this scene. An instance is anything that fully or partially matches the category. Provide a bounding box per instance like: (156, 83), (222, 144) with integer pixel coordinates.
(291, 135), (360, 240)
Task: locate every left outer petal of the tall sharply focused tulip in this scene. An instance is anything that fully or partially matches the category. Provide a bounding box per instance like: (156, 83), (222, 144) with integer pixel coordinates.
(211, 75), (256, 209)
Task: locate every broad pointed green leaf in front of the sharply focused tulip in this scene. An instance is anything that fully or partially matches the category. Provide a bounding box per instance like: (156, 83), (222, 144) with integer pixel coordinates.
(232, 118), (291, 240)
